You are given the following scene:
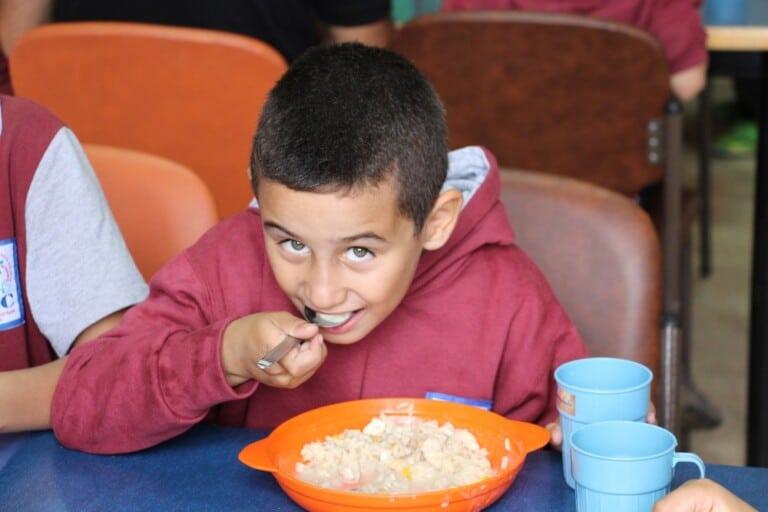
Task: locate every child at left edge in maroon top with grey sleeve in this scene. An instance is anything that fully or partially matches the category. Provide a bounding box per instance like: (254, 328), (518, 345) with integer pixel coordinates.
(0, 96), (147, 432)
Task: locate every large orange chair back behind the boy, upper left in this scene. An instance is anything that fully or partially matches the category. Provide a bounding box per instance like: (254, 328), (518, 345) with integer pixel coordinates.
(10, 22), (287, 217)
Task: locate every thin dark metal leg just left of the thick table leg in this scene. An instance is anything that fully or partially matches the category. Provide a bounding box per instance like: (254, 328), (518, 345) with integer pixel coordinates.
(697, 85), (712, 277)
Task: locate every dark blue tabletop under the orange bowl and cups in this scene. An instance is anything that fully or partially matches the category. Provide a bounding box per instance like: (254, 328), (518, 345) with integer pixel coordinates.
(0, 425), (768, 512)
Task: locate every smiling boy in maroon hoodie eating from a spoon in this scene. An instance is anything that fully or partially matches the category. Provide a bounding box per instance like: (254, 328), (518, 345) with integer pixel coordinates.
(52, 44), (585, 453)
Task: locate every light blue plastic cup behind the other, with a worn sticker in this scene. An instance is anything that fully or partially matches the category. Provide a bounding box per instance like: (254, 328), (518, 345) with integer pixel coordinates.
(555, 357), (653, 489)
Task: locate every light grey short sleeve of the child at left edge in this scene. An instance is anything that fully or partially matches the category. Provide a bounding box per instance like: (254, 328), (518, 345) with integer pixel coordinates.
(25, 128), (148, 356)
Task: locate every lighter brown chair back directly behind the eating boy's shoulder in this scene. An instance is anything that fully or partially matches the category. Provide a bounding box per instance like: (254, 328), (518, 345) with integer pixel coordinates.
(501, 170), (661, 376)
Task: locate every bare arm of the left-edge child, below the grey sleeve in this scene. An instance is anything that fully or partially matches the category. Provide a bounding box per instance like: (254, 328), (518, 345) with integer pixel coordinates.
(0, 311), (124, 433)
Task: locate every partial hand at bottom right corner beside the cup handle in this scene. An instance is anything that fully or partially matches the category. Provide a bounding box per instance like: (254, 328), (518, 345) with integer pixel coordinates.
(653, 478), (756, 512)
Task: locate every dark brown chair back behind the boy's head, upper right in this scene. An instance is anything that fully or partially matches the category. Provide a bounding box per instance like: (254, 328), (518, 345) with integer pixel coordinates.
(392, 11), (669, 194)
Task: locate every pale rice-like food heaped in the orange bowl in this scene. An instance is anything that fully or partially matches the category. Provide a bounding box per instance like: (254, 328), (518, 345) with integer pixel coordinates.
(296, 413), (495, 494)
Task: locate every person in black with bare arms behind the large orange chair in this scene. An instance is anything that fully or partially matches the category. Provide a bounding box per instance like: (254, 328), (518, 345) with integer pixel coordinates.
(0, 0), (392, 62)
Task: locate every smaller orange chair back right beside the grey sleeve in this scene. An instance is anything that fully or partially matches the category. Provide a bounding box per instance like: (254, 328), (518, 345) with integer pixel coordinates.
(84, 144), (218, 280)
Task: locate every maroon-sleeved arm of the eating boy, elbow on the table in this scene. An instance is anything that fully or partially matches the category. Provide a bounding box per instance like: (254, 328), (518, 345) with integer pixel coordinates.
(51, 253), (255, 453)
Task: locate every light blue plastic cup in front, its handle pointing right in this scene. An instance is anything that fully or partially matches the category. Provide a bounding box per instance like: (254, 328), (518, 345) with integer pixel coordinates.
(571, 421), (705, 512)
